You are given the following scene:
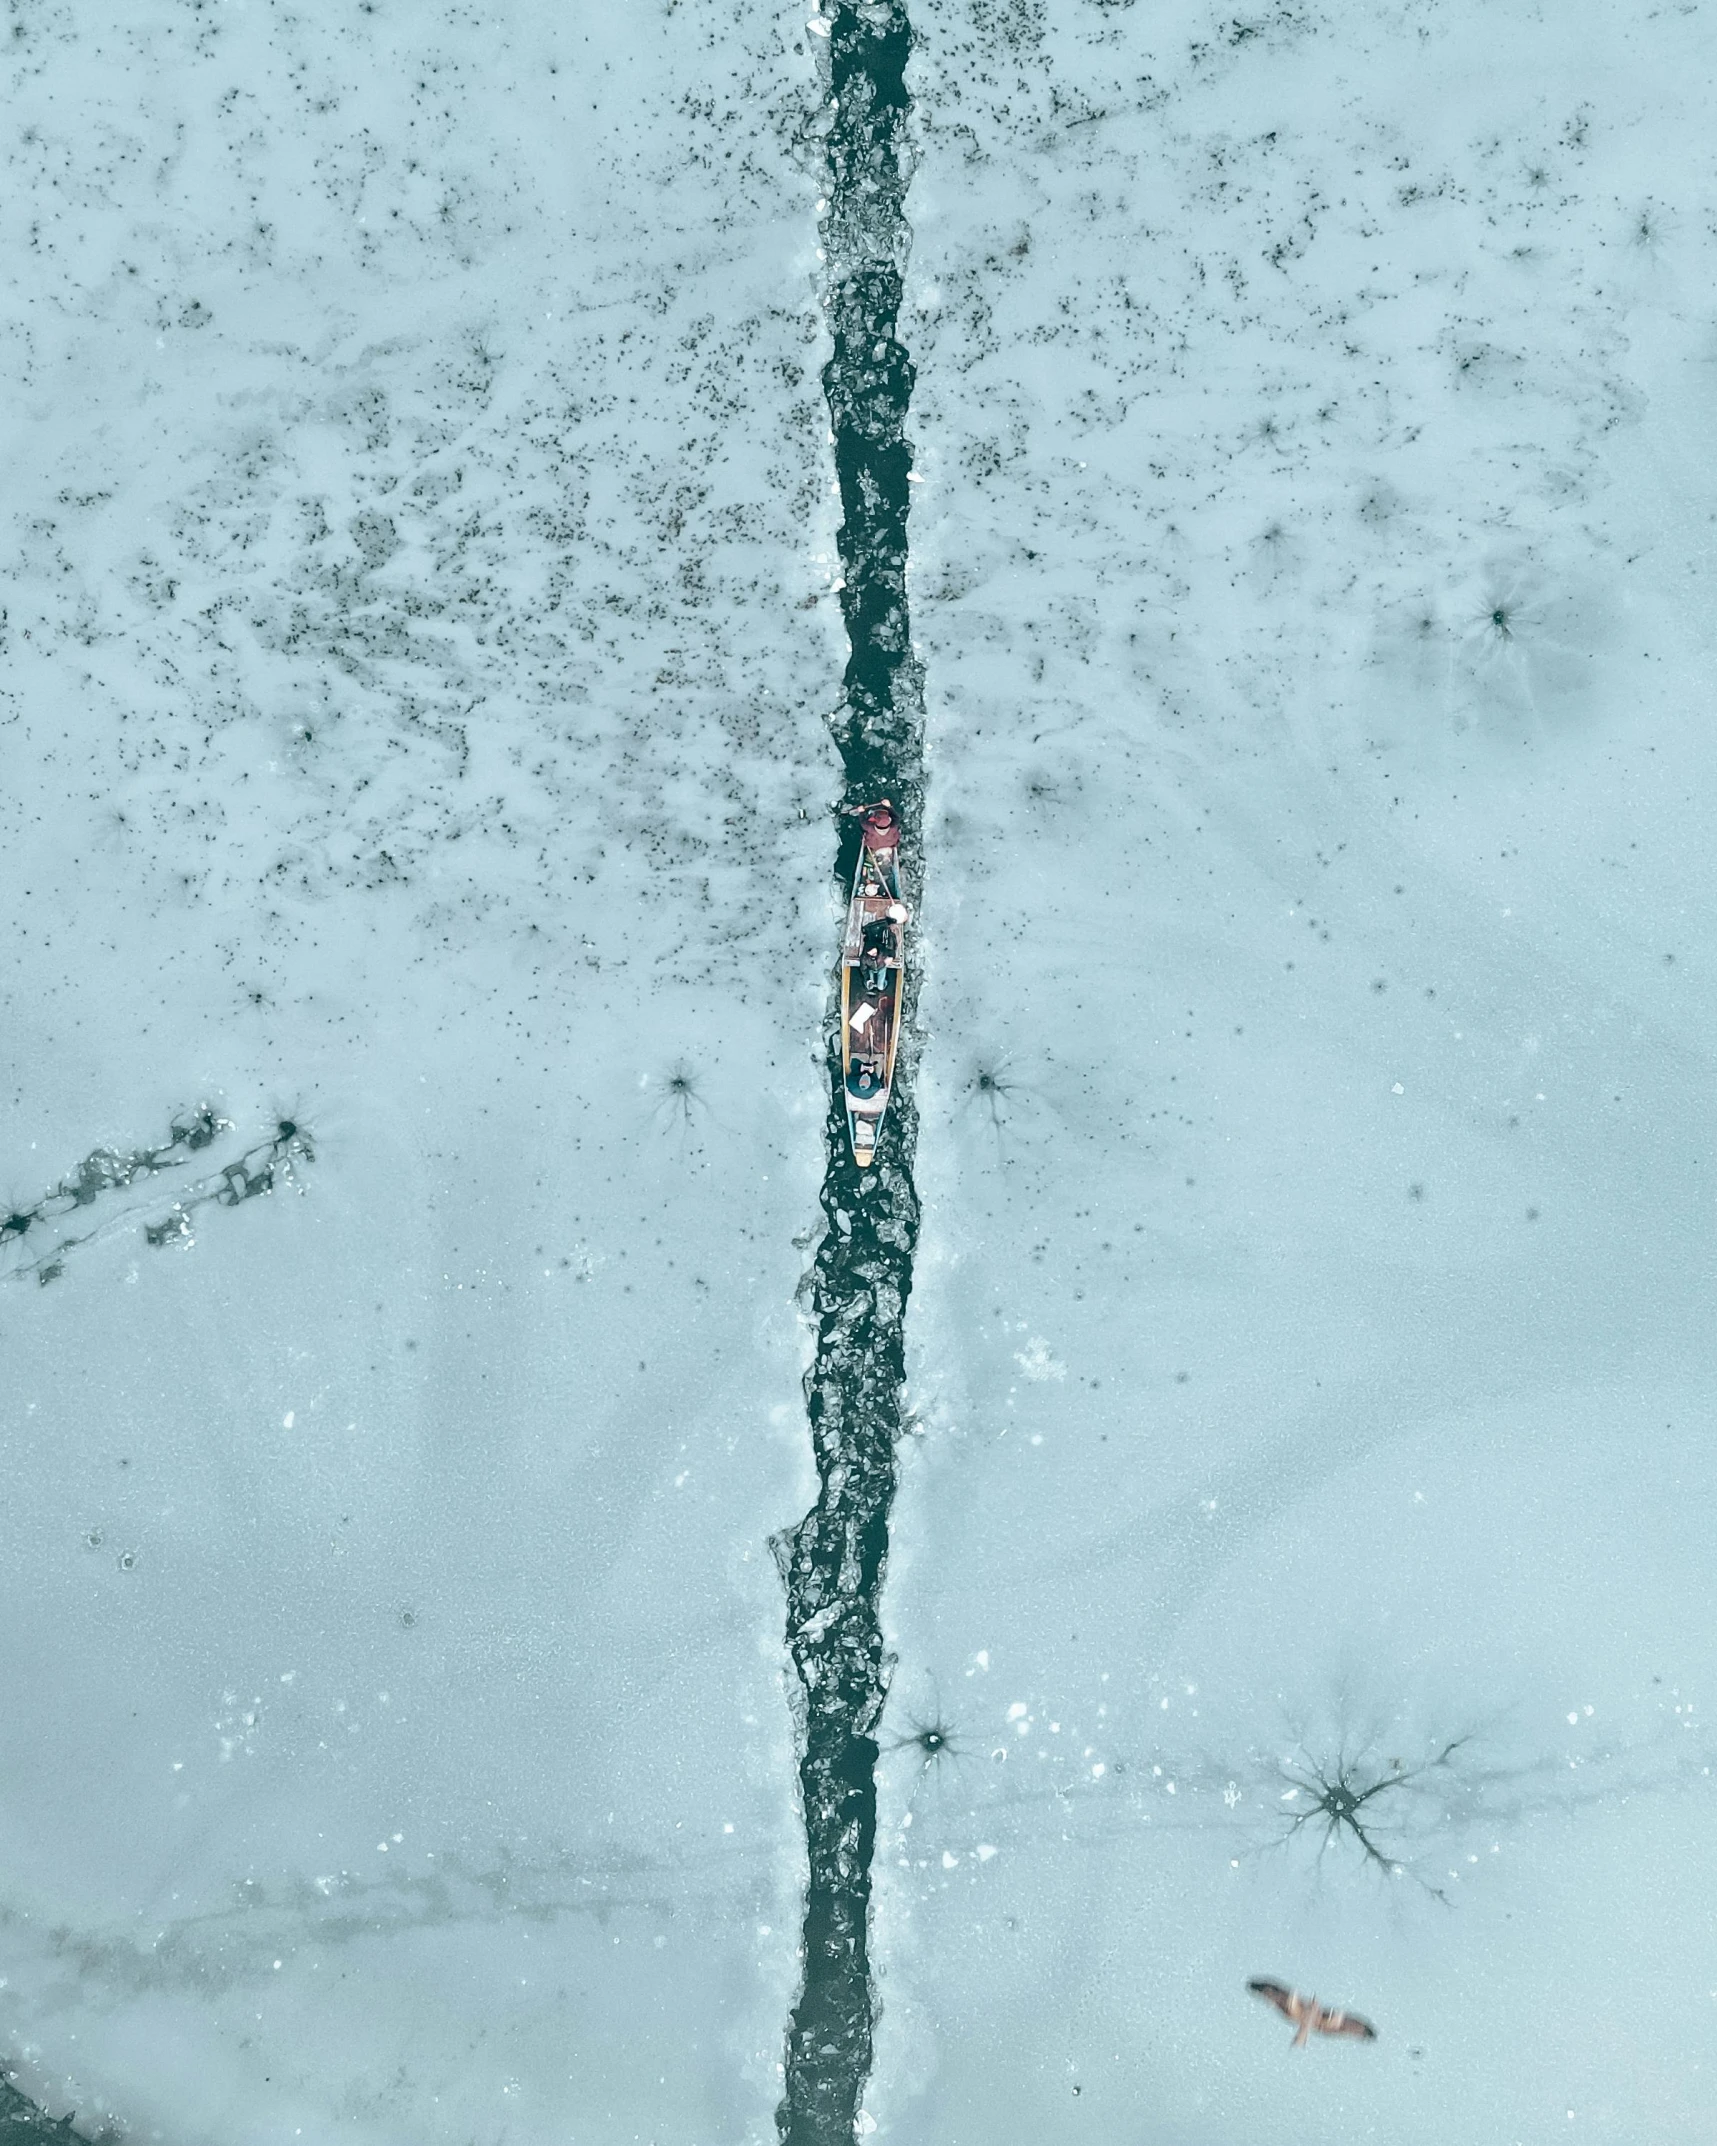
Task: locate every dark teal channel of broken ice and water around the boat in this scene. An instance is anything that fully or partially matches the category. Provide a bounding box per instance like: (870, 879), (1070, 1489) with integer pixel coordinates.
(775, 0), (923, 2146)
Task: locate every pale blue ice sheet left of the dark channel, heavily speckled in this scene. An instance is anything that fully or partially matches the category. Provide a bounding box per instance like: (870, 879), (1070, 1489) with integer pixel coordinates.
(0, 4), (841, 2146)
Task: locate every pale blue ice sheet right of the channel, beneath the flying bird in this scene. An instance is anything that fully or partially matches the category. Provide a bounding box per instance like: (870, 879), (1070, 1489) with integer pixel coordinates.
(867, 0), (1717, 2146)
